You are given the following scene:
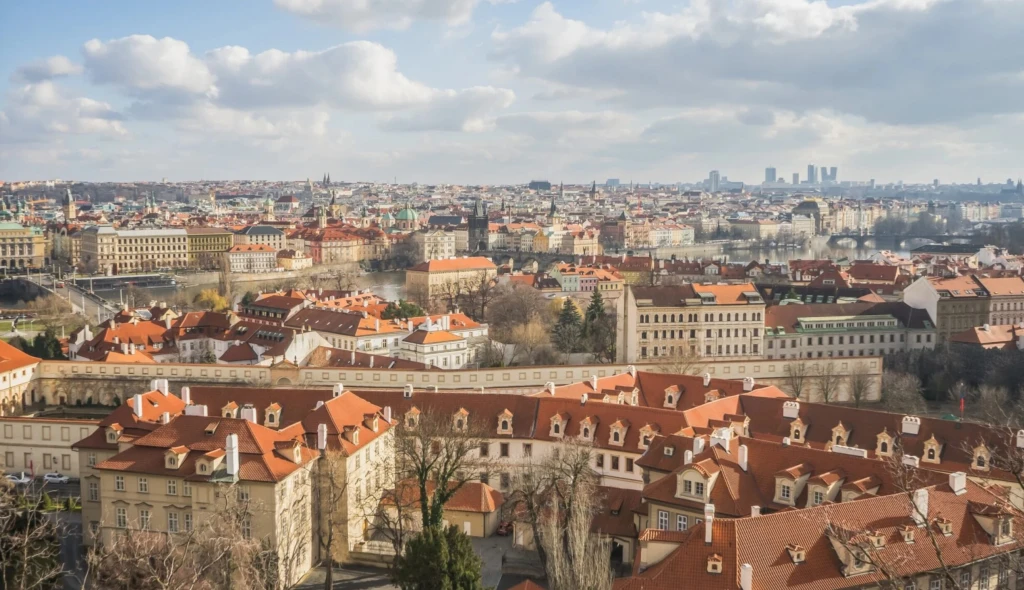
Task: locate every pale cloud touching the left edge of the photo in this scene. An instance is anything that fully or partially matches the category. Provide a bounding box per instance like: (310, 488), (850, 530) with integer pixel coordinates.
(0, 81), (128, 143)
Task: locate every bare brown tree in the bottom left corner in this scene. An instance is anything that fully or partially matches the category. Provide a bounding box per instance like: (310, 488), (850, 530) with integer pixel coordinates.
(0, 479), (65, 590)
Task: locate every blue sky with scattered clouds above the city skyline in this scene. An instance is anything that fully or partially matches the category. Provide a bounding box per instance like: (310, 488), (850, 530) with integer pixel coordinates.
(0, 0), (1024, 184)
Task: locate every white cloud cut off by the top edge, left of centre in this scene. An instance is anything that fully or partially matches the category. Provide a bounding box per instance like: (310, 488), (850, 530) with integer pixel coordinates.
(274, 0), (479, 32)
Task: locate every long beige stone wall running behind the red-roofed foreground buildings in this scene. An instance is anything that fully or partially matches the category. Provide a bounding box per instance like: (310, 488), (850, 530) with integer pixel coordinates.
(36, 356), (882, 406)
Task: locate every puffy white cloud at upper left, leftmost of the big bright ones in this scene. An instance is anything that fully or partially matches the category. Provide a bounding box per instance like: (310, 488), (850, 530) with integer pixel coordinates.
(83, 35), (215, 95)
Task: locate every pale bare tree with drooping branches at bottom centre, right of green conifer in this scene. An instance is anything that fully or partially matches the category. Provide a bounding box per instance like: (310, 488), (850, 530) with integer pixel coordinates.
(507, 440), (613, 590)
